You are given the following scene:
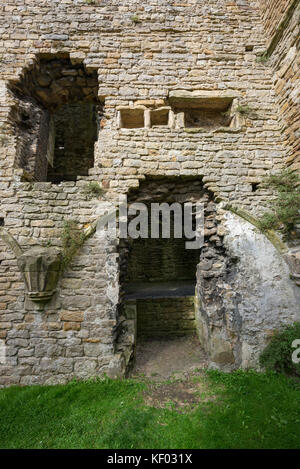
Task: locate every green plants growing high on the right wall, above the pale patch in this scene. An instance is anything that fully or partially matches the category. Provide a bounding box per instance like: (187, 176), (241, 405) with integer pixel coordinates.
(259, 169), (300, 238)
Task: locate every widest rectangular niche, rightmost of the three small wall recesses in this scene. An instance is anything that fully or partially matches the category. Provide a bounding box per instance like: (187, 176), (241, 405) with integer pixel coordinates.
(169, 91), (235, 129)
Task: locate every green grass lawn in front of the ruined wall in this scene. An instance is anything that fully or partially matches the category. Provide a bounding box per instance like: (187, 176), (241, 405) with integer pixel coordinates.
(0, 372), (300, 449)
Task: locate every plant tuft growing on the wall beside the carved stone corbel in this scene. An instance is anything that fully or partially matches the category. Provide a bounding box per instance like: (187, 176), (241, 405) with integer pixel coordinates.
(61, 220), (85, 268)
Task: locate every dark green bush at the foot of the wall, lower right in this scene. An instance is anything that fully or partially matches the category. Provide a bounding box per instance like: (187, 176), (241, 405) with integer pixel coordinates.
(260, 322), (300, 376)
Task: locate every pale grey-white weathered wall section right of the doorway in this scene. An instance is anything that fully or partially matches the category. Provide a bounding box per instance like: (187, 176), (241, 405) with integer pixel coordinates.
(196, 210), (300, 371)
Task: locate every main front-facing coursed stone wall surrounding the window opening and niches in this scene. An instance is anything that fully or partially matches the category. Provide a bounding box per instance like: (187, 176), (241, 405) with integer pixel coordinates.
(0, 0), (293, 385)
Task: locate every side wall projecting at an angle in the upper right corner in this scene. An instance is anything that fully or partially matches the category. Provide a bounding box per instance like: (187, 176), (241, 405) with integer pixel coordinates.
(259, 0), (300, 169)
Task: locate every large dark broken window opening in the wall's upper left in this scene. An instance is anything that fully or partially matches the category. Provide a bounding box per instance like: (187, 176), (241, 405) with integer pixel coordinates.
(11, 56), (100, 183)
